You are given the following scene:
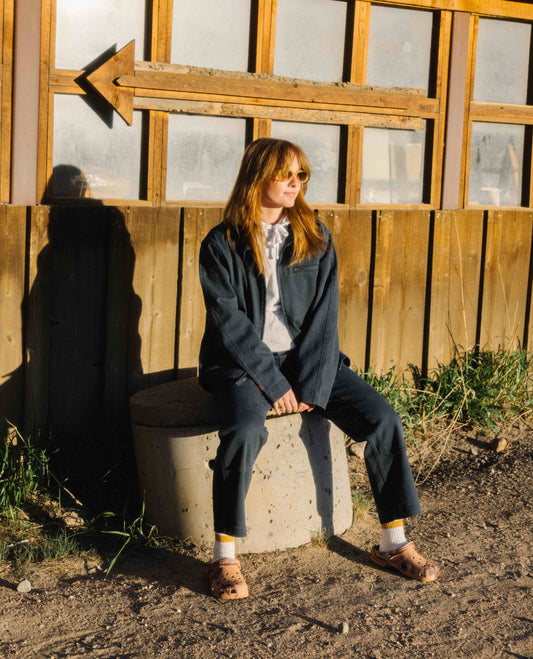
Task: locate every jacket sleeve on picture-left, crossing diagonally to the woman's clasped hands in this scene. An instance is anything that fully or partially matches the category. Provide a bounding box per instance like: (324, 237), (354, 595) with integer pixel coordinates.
(200, 235), (291, 403)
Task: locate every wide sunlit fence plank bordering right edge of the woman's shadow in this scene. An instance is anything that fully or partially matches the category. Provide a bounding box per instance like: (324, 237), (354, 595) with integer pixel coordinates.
(126, 206), (180, 393)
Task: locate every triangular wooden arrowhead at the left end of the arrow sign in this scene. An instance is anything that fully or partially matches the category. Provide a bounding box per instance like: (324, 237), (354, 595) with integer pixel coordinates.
(87, 39), (135, 126)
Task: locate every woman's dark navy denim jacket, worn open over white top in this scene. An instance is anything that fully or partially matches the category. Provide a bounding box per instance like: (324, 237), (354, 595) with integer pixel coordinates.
(200, 223), (347, 407)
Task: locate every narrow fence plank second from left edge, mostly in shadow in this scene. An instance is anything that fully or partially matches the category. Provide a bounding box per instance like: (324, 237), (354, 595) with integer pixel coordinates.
(24, 206), (50, 435)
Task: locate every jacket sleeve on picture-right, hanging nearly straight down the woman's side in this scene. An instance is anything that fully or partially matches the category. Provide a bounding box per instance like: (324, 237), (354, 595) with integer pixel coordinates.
(296, 230), (340, 408)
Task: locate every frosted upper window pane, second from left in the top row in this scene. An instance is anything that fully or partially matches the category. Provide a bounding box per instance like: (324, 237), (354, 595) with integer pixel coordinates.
(171, 0), (251, 71)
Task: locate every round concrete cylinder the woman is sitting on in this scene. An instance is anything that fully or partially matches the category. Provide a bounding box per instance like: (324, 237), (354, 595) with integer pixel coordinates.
(130, 378), (353, 553)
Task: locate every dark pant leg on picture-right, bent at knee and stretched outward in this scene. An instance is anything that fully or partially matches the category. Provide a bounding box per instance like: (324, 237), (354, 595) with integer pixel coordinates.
(317, 364), (421, 524)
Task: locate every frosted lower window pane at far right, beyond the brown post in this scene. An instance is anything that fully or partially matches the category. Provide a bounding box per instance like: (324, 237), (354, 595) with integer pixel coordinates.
(468, 122), (525, 206)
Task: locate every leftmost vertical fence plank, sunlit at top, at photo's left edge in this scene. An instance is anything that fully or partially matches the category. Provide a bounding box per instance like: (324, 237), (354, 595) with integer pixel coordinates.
(0, 206), (26, 433)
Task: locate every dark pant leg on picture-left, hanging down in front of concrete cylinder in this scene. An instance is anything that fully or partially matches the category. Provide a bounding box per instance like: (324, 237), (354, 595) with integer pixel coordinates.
(213, 376), (270, 537)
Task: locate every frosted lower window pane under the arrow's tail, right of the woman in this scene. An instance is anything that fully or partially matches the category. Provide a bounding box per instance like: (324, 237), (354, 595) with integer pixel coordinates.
(361, 128), (426, 204)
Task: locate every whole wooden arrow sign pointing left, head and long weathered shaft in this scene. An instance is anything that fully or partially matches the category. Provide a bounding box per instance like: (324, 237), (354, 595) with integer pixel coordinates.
(83, 41), (432, 130)
